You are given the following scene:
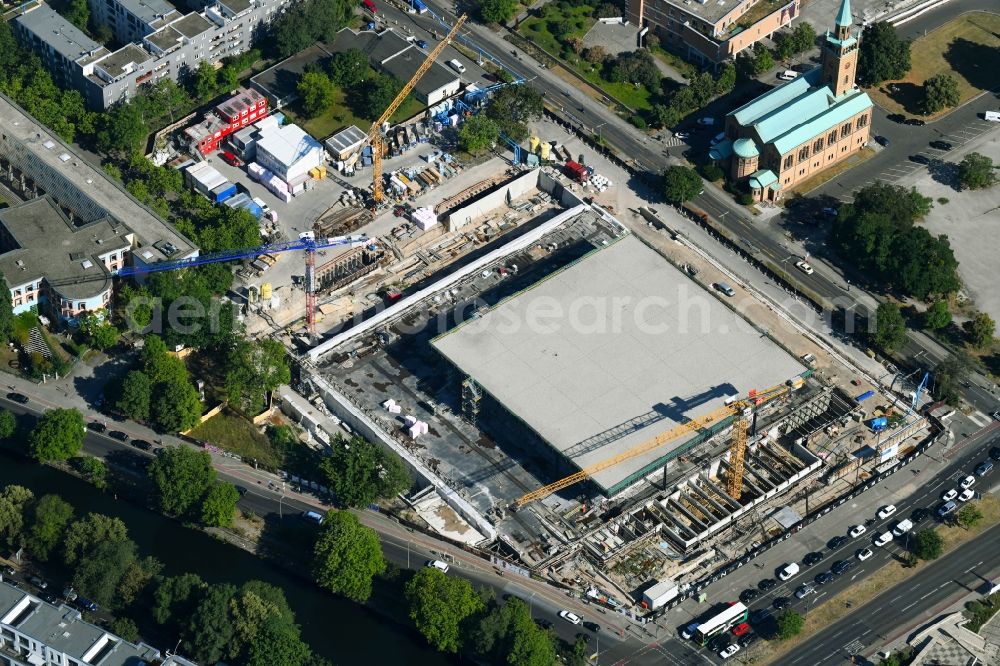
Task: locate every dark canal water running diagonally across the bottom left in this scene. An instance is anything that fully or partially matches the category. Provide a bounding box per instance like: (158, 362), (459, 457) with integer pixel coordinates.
(0, 452), (456, 666)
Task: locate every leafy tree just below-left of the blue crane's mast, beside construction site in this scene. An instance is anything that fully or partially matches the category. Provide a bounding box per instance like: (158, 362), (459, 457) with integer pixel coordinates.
(226, 338), (292, 414)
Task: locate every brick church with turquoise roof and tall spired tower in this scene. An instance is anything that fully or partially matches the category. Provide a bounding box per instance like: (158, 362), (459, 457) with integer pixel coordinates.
(709, 0), (872, 201)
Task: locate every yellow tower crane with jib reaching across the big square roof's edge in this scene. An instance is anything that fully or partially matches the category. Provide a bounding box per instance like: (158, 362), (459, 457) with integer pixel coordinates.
(514, 377), (802, 509)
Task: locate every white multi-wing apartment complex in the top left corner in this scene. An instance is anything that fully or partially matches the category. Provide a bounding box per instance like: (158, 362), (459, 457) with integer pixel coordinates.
(13, 0), (289, 110)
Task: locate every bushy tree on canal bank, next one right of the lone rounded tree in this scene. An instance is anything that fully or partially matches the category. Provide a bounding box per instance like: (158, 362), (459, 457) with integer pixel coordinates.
(405, 567), (485, 652)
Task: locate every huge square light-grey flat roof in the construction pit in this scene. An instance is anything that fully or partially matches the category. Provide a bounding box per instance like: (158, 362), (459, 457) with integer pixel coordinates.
(432, 235), (805, 493)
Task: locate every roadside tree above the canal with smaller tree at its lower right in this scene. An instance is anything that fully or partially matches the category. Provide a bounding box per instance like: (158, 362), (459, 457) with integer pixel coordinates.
(147, 446), (216, 516)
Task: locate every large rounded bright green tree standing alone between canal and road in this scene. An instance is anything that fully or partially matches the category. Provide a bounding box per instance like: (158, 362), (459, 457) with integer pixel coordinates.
(313, 511), (385, 601)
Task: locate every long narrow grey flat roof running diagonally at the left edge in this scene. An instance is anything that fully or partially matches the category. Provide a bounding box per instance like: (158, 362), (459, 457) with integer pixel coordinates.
(0, 95), (198, 263)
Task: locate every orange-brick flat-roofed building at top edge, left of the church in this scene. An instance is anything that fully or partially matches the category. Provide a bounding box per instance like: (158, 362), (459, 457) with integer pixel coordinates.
(628, 0), (799, 66)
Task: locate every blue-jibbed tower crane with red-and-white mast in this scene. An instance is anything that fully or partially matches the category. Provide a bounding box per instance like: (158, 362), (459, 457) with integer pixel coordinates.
(114, 231), (371, 337)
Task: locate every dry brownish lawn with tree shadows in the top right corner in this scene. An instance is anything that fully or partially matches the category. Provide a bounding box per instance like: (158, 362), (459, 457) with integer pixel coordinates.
(868, 12), (1000, 118)
